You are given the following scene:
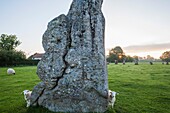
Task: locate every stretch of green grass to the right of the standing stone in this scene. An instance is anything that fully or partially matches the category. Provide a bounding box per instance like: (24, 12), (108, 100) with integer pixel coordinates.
(108, 63), (170, 113)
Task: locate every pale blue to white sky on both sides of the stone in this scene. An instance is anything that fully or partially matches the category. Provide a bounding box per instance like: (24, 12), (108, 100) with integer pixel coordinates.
(0, 0), (170, 58)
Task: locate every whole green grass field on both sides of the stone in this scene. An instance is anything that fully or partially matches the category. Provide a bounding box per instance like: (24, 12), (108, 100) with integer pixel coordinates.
(0, 63), (170, 113)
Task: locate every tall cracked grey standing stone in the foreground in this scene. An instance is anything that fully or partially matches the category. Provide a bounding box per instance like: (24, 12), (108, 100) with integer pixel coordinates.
(31, 0), (108, 112)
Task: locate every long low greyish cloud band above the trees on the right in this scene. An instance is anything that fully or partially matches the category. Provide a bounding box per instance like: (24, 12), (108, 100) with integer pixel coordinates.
(123, 42), (170, 53)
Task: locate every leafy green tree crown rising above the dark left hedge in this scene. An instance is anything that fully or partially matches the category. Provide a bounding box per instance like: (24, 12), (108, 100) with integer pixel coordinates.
(0, 34), (21, 51)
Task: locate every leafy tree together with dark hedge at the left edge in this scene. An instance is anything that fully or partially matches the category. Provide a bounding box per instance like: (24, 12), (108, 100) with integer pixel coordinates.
(0, 34), (38, 66)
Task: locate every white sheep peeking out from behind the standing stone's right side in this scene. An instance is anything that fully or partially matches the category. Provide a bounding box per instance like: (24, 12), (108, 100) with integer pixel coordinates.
(108, 90), (118, 108)
